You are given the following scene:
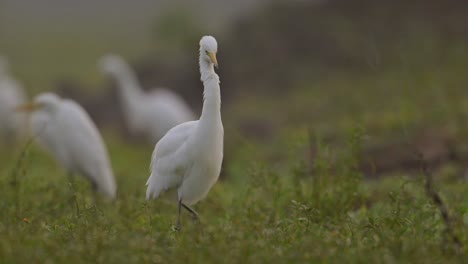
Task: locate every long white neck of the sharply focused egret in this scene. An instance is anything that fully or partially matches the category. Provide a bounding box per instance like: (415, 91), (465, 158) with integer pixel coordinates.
(200, 55), (221, 126)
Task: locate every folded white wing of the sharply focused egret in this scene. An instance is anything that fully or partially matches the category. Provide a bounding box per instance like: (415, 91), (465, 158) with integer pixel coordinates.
(146, 120), (198, 199)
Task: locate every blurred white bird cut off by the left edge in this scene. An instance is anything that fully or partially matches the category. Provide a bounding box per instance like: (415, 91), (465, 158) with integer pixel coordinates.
(0, 57), (27, 143)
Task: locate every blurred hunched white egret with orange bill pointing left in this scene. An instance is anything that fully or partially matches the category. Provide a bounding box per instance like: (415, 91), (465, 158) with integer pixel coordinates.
(17, 93), (117, 198)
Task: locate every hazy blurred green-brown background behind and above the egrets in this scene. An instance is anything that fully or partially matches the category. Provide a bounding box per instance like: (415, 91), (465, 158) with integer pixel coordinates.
(0, 0), (468, 175)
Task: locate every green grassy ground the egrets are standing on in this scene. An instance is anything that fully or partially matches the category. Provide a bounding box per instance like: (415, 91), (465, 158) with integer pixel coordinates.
(0, 125), (468, 263)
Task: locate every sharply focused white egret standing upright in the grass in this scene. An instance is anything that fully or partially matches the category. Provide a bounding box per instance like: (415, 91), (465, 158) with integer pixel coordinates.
(146, 36), (224, 228)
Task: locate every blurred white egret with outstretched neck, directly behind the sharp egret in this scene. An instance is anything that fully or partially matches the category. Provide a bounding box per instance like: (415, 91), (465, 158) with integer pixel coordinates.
(99, 55), (195, 144)
